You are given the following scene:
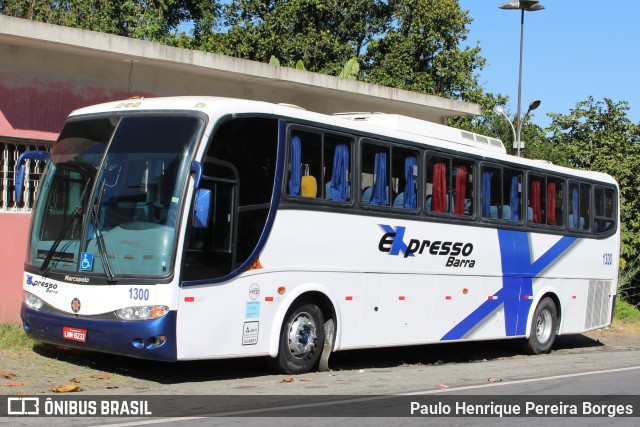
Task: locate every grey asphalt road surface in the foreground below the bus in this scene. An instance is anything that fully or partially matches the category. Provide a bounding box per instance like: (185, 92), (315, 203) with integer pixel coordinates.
(5, 335), (640, 427)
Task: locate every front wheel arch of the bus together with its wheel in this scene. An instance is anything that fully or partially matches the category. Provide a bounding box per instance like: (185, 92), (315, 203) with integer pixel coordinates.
(269, 291), (337, 374)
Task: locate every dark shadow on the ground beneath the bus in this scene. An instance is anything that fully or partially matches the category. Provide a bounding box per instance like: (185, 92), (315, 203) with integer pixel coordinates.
(27, 335), (604, 384)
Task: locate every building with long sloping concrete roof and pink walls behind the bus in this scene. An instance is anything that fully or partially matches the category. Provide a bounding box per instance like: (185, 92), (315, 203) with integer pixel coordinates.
(0, 15), (480, 322)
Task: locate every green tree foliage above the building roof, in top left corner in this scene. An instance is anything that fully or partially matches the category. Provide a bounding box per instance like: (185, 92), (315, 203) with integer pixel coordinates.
(0, 0), (220, 44)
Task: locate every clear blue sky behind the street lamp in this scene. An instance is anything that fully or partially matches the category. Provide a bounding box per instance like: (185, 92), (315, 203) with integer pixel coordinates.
(458, 0), (640, 128)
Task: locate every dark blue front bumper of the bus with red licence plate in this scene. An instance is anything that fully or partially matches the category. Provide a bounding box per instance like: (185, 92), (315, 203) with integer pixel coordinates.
(20, 303), (177, 361)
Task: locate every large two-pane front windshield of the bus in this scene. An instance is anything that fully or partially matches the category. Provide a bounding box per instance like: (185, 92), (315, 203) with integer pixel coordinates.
(28, 114), (204, 282)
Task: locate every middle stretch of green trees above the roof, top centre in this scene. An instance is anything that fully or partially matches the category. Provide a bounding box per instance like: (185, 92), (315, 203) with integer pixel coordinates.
(197, 0), (386, 75)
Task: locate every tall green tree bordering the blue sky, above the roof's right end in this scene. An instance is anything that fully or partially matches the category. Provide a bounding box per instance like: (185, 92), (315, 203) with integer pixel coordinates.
(363, 0), (486, 100)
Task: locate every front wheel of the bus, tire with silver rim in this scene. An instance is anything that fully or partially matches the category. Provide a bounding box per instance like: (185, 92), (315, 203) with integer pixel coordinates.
(272, 302), (324, 375)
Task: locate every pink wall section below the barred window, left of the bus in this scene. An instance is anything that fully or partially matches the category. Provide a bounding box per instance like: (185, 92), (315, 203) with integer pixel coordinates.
(0, 212), (31, 323)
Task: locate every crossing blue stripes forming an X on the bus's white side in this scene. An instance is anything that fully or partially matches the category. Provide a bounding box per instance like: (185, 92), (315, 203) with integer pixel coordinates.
(441, 230), (577, 341)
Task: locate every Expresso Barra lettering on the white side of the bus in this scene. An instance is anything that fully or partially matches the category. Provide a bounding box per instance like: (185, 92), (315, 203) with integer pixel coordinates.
(378, 224), (476, 268)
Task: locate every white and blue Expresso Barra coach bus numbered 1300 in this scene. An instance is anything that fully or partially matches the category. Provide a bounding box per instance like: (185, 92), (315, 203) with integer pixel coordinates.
(16, 97), (620, 374)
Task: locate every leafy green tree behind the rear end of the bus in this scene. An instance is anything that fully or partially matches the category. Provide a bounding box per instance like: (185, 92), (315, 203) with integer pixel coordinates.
(547, 97), (640, 304)
